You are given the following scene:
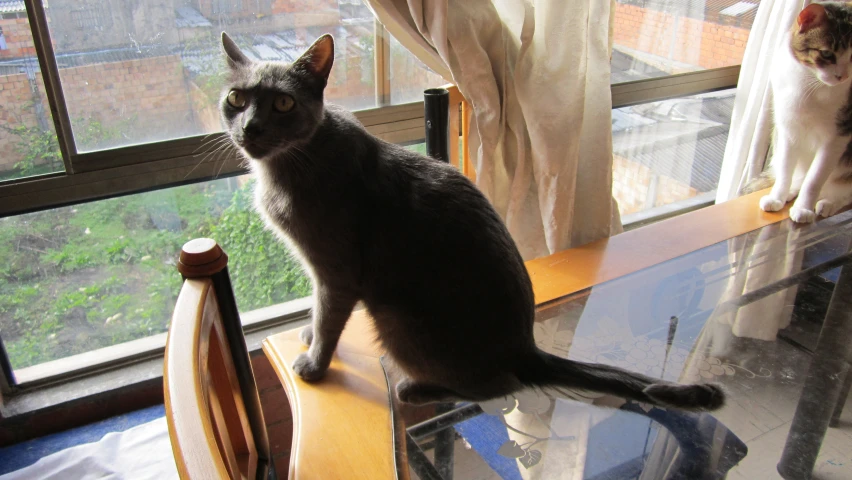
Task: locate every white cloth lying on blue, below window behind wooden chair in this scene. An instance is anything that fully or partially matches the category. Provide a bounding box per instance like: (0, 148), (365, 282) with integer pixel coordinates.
(0, 417), (178, 480)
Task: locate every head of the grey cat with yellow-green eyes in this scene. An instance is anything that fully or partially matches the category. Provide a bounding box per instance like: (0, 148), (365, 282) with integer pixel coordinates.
(220, 33), (334, 160)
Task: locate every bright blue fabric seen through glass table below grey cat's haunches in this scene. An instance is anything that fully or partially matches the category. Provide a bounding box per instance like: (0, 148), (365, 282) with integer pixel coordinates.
(455, 415), (522, 480)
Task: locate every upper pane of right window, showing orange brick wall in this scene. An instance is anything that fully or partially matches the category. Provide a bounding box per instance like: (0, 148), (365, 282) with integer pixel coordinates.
(612, 0), (760, 83)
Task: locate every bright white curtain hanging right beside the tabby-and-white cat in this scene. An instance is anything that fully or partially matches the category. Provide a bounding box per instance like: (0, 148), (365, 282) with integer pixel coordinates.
(716, 0), (810, 203)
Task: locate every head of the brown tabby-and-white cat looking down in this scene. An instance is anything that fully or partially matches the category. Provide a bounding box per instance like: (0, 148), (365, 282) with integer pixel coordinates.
(790, 2), (852, 86)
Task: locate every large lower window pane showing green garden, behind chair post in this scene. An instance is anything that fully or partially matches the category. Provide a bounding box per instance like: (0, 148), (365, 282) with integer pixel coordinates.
(0, 176), (310, 369)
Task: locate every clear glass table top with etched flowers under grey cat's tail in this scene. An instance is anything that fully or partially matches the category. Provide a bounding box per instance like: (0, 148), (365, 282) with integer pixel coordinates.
(388, 212), (852, 480)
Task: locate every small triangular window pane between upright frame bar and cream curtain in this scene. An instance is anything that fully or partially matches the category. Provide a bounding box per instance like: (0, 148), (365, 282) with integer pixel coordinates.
(390, 37), (450, 105)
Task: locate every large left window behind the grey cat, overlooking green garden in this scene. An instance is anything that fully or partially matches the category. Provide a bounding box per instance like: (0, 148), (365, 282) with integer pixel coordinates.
(0, 0), (445, 386)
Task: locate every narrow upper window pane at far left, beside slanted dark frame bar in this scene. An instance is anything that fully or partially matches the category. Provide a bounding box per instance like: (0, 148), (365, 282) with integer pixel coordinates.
(0, 9), (65, 181)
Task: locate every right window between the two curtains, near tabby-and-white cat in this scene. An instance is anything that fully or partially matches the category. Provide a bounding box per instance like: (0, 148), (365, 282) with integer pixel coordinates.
(611, 0), (758, 223)
